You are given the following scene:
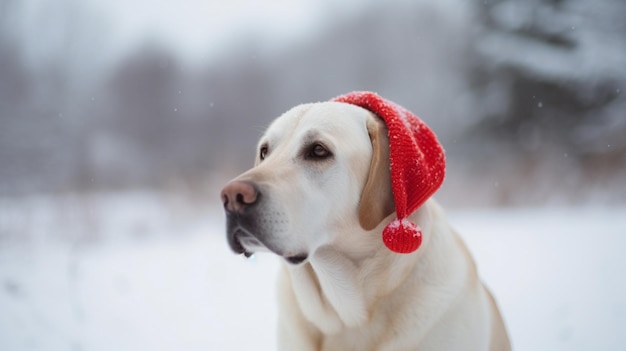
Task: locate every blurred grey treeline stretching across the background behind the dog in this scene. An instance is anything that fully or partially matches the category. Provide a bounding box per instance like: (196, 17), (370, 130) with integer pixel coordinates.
(0, 0), (626, 204)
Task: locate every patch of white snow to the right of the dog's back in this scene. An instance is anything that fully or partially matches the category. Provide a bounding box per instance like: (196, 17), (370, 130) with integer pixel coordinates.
(452, 207), (626, 350)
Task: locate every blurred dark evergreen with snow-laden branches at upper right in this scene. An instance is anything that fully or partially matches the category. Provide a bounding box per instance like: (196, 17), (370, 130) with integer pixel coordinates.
(472, 0), (626, 169)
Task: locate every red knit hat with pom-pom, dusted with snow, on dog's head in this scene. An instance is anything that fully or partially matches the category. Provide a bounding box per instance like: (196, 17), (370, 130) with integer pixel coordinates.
(333, 91), (446, 253)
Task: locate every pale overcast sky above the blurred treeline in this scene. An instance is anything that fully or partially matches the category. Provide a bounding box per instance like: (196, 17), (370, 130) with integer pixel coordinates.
(3, 0), (390, 67)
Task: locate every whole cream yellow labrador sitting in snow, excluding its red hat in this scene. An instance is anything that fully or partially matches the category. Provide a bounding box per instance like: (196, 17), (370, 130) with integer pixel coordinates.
(222, 102), (510, 351)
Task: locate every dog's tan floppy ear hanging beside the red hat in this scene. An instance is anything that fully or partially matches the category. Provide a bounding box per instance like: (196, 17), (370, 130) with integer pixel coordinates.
(359, 117), (395, 230)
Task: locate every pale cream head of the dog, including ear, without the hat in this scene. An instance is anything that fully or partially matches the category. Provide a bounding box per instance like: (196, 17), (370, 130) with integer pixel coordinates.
(221, 102), (394, 264)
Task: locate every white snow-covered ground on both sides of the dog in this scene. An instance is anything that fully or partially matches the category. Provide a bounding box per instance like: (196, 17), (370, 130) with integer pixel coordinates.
(0, 192), (626, 351)
